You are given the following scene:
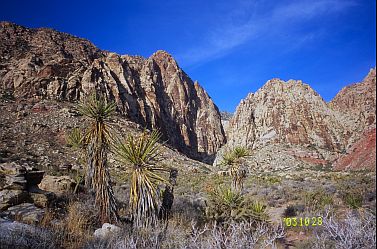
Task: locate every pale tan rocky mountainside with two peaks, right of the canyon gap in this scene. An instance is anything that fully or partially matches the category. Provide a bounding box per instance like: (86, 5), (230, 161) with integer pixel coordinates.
(215, 69), (376, 170)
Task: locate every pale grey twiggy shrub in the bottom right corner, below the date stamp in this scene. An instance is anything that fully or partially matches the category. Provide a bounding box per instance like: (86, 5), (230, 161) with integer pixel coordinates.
(311, 210), (376, 249)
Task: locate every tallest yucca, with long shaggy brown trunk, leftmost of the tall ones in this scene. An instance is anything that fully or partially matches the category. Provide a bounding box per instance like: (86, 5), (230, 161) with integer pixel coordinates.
(78, 94), (118, 222)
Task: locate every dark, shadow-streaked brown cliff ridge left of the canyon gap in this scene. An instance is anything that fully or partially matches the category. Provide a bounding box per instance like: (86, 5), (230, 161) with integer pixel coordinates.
(0, 22), (225, 161)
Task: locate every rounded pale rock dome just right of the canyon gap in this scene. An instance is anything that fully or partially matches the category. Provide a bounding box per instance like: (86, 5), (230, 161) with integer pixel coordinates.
(223, 79), (345, 151)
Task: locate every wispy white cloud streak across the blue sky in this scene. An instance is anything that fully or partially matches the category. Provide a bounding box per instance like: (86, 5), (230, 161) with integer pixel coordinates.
(177, 0), (356, 65)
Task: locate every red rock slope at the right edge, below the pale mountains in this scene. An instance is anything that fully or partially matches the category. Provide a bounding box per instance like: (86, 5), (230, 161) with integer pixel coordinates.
(333, 129), (376, 170)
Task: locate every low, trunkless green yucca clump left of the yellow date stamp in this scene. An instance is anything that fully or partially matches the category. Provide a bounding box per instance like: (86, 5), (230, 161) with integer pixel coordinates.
(206, 187), (268, 224)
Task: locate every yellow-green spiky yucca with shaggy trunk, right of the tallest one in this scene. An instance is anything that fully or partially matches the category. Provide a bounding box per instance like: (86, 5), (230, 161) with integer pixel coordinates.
(115, 130), (168, 227)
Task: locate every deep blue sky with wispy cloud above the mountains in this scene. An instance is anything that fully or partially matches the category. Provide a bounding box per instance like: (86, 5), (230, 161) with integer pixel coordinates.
(0, 0), (376, 111)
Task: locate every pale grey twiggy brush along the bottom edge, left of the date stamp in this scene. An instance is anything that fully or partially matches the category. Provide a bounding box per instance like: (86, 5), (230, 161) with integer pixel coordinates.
(84, 222), (285, 249)
